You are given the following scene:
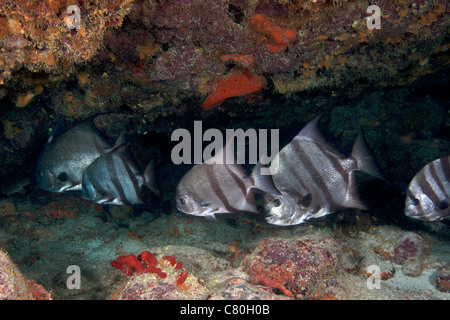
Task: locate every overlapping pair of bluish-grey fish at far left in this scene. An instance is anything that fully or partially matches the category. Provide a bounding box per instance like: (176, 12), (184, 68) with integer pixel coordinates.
(36, 117), (160, 205)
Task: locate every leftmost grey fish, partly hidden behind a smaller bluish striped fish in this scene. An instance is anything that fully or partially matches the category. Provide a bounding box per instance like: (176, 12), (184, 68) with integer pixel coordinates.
(35, 116), (124, 192)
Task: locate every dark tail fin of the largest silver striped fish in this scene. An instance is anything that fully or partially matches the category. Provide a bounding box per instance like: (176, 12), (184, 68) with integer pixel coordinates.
(351, 130), (386, 180)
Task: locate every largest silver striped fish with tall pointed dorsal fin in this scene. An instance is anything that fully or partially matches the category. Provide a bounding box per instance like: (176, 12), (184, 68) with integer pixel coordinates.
(264, 115), (383, 226)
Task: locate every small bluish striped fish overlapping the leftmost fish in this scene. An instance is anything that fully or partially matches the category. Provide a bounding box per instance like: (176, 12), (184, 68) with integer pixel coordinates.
(81, 143), (161, 205)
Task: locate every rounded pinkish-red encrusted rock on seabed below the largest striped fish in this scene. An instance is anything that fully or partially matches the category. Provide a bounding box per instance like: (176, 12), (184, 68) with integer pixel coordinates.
(243, 234), (340, 298)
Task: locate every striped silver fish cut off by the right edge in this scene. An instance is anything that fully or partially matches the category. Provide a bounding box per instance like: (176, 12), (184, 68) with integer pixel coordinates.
(405, 155), (450, 221)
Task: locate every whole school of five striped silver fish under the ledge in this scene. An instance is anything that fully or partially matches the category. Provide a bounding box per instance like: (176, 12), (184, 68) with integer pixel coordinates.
(35, 115), (450, 226)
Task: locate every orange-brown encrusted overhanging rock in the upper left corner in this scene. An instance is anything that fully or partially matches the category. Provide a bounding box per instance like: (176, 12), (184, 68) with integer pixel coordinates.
(0, 0), (133, 84)
